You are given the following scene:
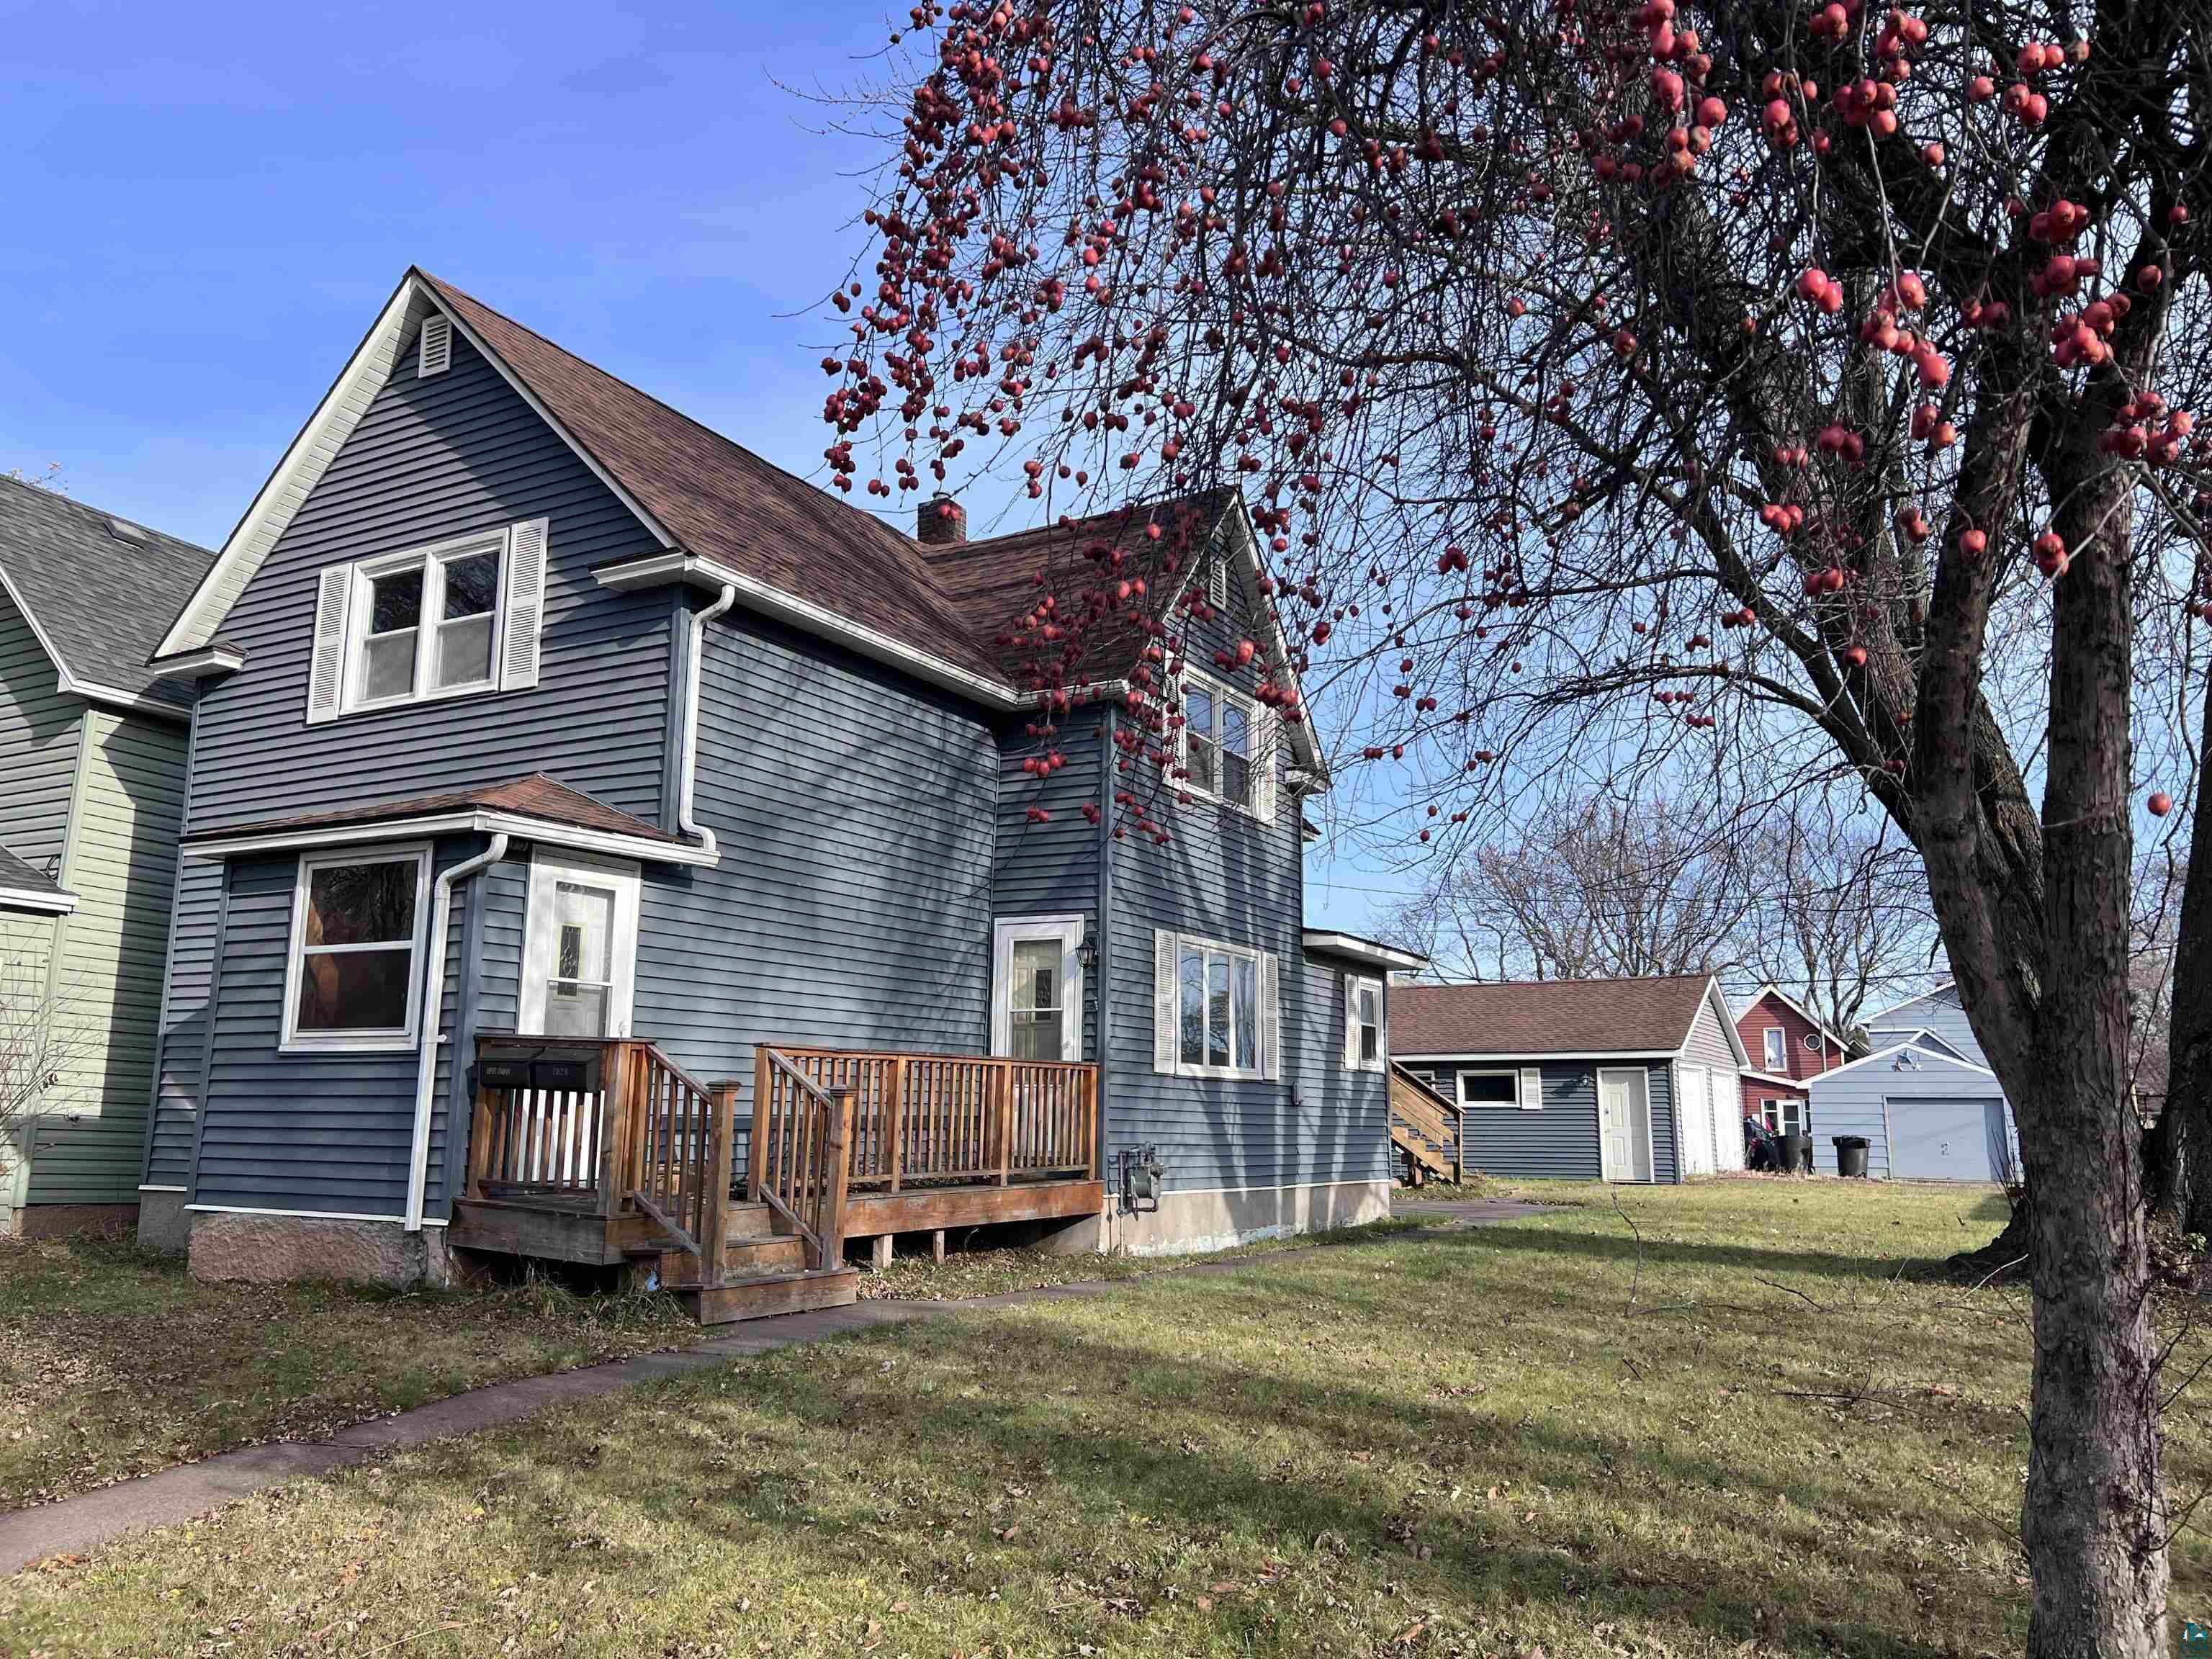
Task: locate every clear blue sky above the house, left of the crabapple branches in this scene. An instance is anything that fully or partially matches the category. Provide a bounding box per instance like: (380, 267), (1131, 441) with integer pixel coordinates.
(0, 0), (1401, 927)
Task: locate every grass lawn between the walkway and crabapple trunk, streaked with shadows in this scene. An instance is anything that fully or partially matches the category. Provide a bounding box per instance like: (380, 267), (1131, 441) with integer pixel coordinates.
(13, 1181), (2212, 1659)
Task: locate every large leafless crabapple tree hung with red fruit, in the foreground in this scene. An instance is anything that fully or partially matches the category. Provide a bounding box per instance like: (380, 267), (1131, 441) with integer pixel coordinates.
(823, 0), (2212, 1657)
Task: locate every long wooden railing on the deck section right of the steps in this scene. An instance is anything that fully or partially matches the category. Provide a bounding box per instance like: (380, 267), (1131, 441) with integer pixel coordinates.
(755, 1046), (1097, 1192)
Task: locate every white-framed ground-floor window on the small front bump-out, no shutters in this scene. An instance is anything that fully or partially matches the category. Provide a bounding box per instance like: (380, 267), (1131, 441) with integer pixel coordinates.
(283, 848), (429, 1048)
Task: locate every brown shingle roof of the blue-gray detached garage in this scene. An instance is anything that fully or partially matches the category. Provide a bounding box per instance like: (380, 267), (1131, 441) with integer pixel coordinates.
(1389, 974), (1712, 1055)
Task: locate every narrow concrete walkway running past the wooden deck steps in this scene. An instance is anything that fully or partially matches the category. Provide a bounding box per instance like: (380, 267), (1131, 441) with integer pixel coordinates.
(0, 1201), (1539, 1573)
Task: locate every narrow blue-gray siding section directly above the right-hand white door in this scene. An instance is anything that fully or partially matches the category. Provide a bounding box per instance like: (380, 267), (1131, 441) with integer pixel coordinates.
(991, 710), (1112, 1059)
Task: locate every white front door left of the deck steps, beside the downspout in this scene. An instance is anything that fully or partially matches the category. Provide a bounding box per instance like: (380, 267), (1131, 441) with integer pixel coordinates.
(516, 850), (637, 1038)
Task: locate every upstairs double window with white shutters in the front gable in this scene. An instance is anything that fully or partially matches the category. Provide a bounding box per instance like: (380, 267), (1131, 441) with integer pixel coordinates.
(307, 518), (547, 721)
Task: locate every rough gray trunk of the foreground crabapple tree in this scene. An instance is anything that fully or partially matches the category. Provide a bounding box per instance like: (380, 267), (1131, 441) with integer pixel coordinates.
(2004, 457), (2168, 1659)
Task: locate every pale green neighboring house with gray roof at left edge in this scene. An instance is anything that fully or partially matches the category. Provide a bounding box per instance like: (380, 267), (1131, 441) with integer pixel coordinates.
(0, 478), (215, 1234)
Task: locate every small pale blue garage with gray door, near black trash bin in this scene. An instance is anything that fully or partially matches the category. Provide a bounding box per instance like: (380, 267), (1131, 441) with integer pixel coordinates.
(1807, 1033), (2020, 1181)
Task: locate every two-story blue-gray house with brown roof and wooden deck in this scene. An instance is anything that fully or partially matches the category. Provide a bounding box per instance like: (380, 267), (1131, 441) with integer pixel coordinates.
(142, 270), (1413, 1318)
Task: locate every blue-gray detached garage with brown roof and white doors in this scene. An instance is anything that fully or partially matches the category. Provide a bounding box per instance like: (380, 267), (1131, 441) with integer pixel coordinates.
(1391, 974), (1750, 1184)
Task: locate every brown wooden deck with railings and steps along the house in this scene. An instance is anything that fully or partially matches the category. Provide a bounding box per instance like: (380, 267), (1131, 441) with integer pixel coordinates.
(447, 1033), (1106, 1323)
